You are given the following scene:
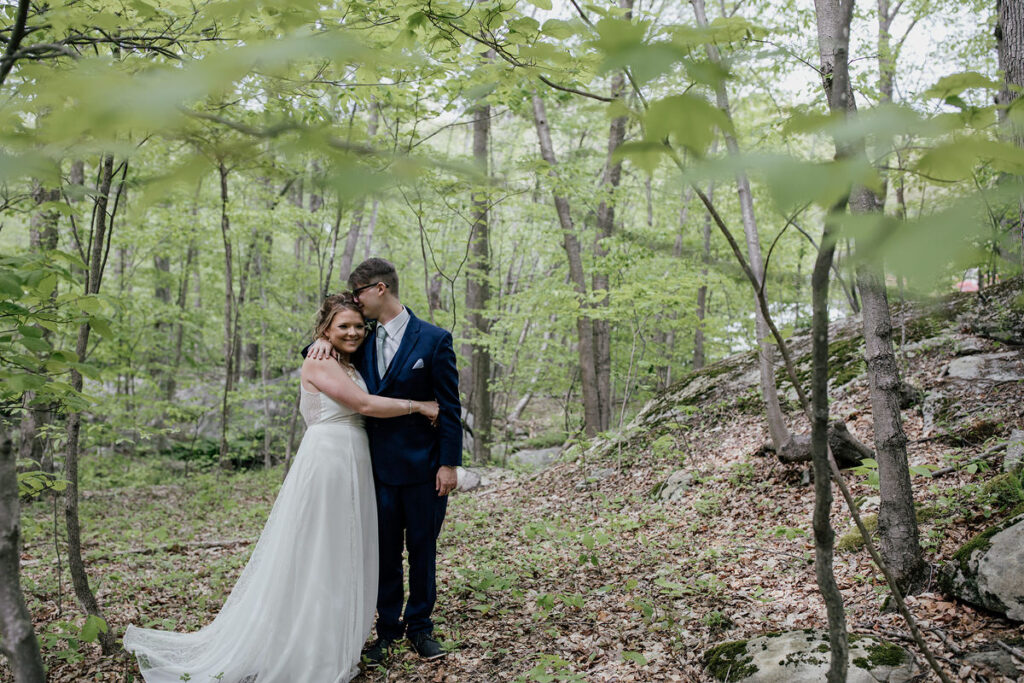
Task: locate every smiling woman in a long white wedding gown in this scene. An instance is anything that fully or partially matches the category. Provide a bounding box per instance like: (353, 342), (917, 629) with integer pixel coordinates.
(124, 294), (437, 683)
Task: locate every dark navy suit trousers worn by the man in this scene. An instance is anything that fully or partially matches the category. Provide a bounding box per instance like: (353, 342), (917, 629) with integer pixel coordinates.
(377, 480), (447, 640)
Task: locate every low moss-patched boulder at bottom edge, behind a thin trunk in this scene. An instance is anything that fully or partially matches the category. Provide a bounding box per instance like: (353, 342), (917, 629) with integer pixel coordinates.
(705, 629), (916, 683)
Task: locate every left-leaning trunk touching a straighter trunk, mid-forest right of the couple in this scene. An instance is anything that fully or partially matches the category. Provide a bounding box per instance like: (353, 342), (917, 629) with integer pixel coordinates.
(534, 92), (601, 436)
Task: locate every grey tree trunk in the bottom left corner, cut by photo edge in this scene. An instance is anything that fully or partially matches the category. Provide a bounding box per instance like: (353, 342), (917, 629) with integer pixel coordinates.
(0, 416), (46, 683)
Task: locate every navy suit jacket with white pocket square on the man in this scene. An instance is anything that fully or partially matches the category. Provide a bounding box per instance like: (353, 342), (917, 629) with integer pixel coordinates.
(352, 310), (462, 486)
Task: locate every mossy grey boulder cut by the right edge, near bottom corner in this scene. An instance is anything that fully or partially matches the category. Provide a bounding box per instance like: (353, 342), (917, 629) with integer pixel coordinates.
(939, 514), (1024, 622)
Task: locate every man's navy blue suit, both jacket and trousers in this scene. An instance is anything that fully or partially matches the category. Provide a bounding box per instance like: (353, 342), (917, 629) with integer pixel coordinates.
(352, 310), (462, 640)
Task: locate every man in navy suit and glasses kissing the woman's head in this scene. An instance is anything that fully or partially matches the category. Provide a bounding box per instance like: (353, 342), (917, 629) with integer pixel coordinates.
(310, 258), (462, 664)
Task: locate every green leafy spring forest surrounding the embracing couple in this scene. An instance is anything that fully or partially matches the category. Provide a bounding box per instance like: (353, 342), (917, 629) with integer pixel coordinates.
(0, 0), (1024, 683)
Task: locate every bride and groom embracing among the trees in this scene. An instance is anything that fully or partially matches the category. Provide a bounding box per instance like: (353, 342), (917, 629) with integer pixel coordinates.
(124, 258), (462, 683)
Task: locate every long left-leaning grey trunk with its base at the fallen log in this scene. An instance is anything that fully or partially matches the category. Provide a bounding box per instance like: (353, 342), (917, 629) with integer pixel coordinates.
(690, 0), (791, 452)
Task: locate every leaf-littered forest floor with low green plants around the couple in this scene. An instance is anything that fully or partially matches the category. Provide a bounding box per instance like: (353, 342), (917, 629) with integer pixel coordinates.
(14, 290), (1024, 682)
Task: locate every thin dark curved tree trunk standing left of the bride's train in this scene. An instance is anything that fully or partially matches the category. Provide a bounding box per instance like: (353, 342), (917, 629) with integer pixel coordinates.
(65, 156), (115, 655)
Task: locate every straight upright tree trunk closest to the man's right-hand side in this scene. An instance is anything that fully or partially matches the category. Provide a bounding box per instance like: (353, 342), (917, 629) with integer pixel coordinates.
(463, 90), (494, 464)
